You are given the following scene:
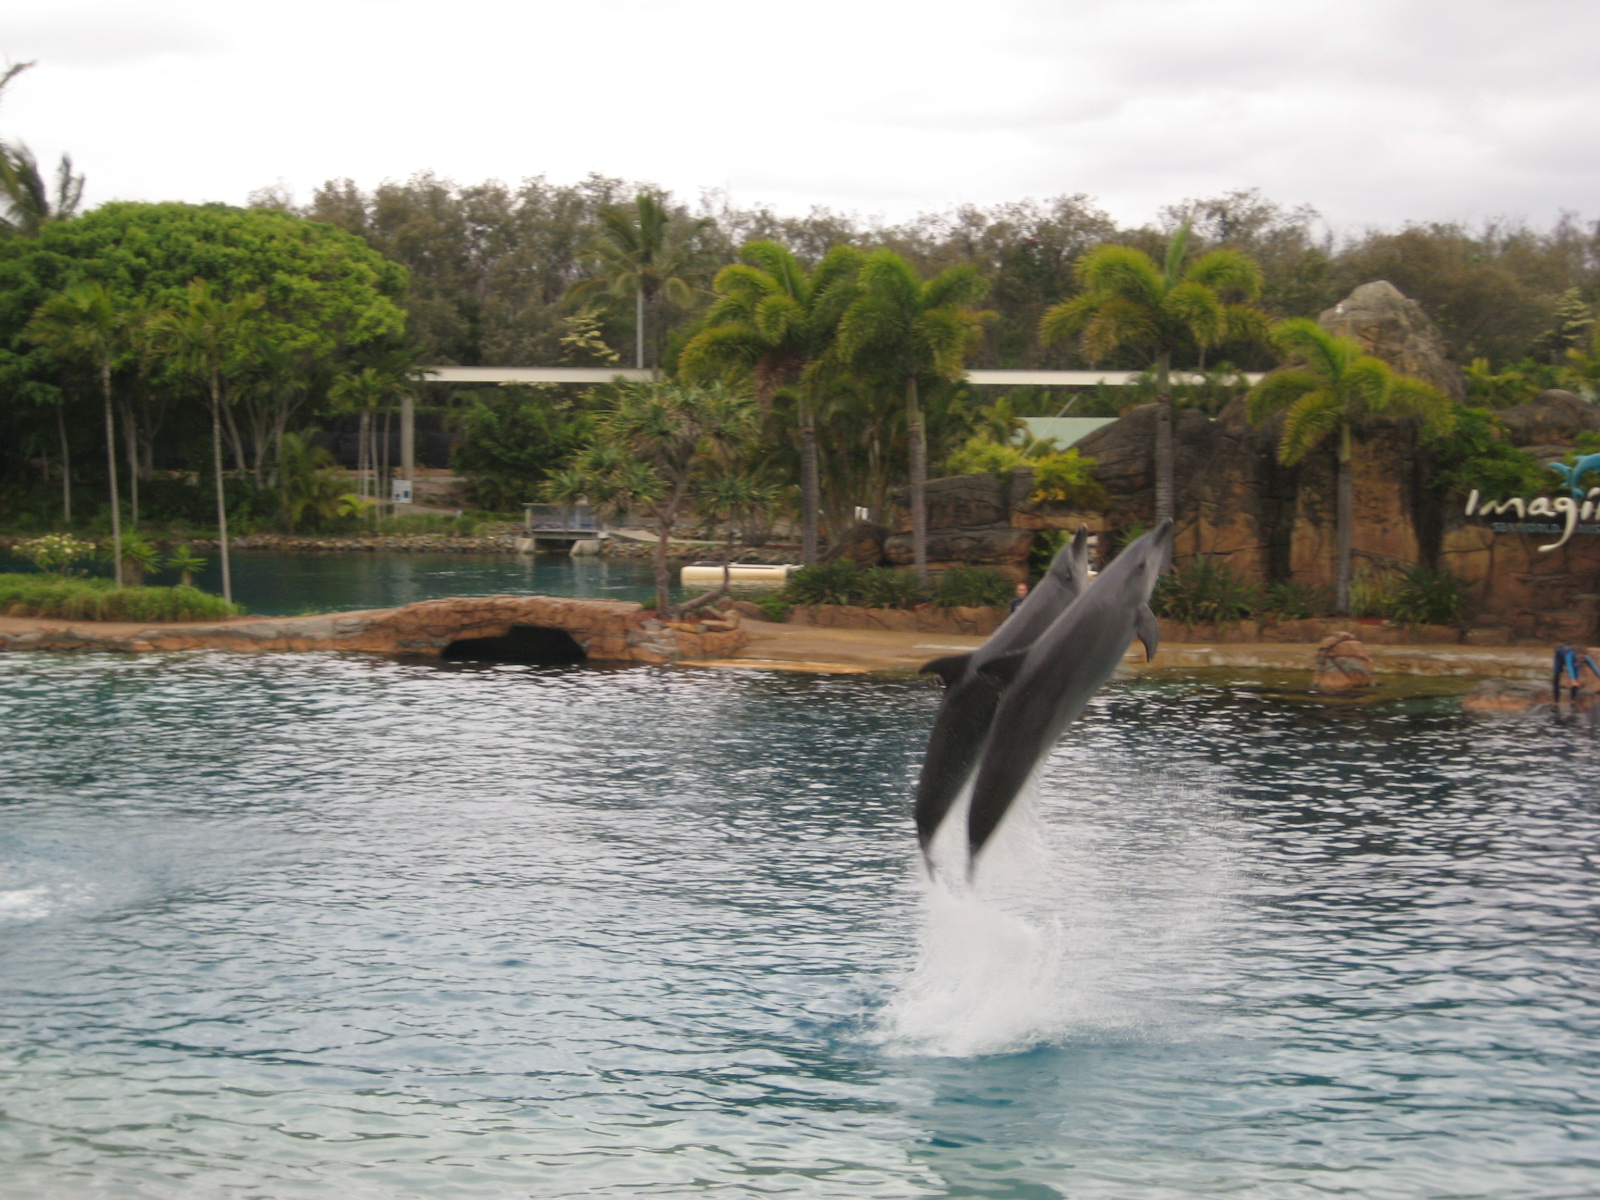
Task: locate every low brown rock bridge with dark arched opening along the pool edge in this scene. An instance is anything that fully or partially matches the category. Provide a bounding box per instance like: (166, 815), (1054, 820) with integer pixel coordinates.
(0, 595), (749, 662)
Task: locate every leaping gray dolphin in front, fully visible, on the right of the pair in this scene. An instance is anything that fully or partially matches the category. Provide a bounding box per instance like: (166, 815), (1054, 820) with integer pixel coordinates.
(966, 520), (1173, 862)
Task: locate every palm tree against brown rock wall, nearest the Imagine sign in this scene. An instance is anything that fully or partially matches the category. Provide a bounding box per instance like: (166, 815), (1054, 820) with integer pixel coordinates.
(1245, 318), (1456, 616)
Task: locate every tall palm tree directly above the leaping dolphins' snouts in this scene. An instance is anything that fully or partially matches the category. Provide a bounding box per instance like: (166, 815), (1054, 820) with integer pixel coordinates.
(1038, 224), (1267, 522)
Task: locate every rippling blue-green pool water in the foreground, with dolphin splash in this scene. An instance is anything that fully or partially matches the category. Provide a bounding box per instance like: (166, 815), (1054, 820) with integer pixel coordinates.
(0, 654), (1600, 1200)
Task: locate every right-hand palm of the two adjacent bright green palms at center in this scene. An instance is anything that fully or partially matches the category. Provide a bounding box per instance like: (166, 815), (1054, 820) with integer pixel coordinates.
(824, 250), (989, 584)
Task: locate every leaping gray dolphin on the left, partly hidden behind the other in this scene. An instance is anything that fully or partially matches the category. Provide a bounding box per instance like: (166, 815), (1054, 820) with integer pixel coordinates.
(915, 525), (1090, 856)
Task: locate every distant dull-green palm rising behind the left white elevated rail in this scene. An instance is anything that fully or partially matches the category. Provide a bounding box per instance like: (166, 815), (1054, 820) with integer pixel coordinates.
(568, 192), (712, 368)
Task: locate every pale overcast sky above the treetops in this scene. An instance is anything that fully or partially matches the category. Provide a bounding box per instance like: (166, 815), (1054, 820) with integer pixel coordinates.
(0, 0), (1600, 229)
